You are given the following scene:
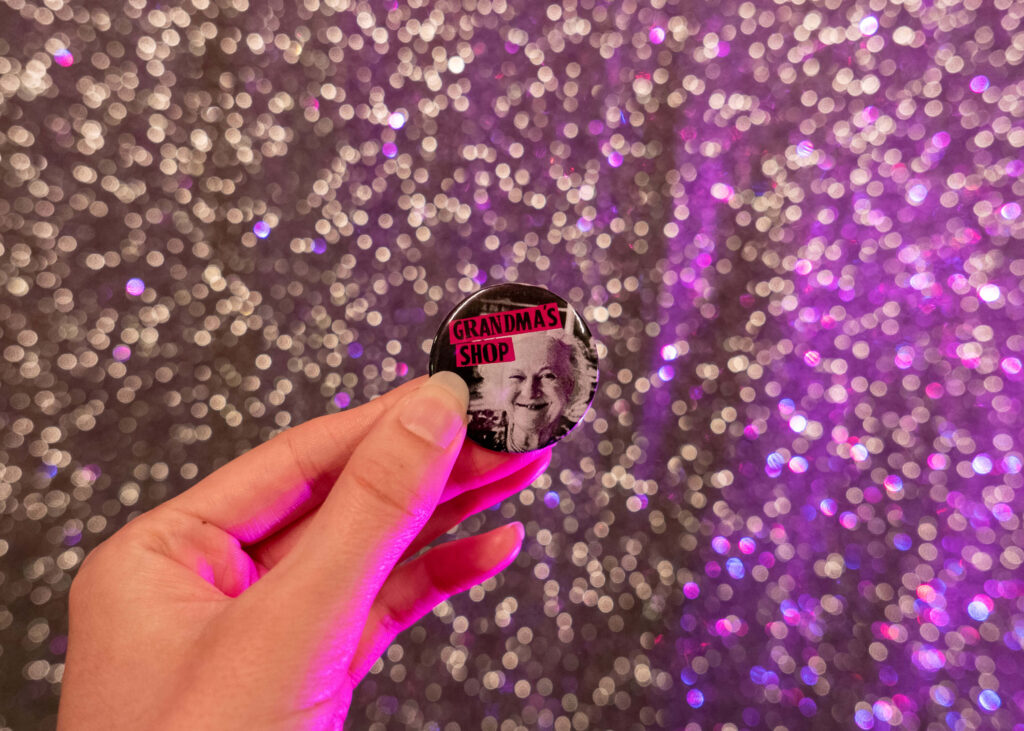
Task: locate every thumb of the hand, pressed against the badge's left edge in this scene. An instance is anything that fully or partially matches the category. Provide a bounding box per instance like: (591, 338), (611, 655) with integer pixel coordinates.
(266, 372), (469, 647)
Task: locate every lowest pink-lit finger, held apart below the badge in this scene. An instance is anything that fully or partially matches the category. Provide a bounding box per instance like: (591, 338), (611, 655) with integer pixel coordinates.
(349, 522), (525, 685)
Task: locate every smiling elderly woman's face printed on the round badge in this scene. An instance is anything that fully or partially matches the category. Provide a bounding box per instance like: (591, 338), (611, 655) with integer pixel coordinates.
(502, 336), (574, 432)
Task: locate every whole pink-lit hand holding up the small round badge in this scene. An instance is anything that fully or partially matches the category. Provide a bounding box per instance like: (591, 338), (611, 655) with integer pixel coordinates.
(58, 373), (550, 731)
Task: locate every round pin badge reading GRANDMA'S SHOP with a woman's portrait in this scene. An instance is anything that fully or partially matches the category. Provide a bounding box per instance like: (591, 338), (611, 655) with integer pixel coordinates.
(430, 285), (597, 452)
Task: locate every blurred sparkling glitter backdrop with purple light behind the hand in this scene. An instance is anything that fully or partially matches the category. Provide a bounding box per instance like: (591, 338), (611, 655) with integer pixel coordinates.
(0, 0), (1024, 731)
